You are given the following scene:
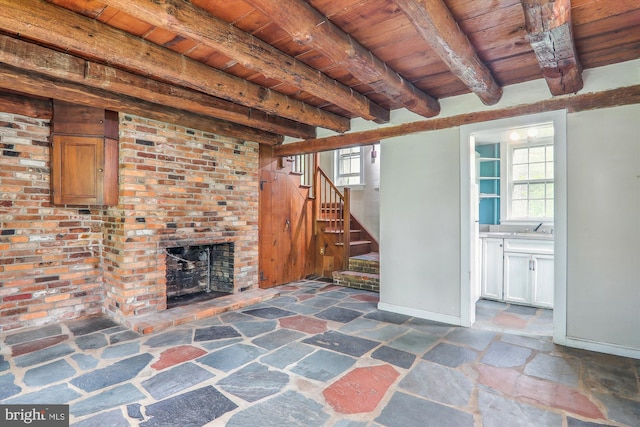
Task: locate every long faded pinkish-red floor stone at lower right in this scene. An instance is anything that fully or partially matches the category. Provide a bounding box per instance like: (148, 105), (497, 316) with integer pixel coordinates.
(478, 365), (604, 419)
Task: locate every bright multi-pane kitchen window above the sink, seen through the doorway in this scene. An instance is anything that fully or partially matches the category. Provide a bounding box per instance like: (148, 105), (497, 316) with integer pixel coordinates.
(508, 139), (554, 220)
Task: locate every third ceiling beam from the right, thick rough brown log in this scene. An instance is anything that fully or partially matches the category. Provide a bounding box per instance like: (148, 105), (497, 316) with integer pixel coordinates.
(244, 0), (440, 117)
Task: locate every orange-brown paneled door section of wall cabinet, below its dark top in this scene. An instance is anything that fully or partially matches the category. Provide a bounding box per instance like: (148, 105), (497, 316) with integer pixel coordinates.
(51, 135), (118, 206)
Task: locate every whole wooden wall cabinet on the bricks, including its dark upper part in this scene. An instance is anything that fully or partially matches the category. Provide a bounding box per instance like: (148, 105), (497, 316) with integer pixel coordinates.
(51, 100), (118, 206)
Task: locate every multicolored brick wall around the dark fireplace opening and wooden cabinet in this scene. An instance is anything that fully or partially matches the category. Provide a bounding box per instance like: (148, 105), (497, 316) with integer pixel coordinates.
(0, 112), (258, 330)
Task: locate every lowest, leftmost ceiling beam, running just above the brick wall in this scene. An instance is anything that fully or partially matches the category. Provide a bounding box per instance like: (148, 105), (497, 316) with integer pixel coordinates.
(0, 64), (284, 145)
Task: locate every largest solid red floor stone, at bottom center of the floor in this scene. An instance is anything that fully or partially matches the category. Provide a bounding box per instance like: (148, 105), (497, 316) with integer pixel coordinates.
(322, 365), (400, 414)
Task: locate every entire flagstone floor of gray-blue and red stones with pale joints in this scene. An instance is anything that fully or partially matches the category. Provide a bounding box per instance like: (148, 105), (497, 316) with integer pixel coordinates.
(0, 280), (640, 427)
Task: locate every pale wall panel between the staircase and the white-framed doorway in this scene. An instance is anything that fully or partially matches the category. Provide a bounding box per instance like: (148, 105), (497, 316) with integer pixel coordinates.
(380, 128), (460, 324)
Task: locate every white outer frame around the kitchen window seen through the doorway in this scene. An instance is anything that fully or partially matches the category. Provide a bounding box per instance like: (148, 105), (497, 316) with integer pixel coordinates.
(500, 137), (555, 224)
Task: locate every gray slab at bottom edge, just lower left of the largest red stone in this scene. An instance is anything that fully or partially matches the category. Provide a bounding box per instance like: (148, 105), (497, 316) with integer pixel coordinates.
(226, 391), (330, 427)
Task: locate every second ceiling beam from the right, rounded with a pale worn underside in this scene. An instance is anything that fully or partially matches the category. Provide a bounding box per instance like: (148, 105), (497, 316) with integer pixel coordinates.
(395, 0), (502, 105)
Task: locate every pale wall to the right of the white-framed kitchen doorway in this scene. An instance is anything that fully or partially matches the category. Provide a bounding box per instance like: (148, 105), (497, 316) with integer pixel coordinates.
(567, 105), (640, 350)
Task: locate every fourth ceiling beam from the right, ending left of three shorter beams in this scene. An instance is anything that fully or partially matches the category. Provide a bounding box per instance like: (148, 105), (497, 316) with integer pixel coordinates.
(102, 0), (389, 123)
